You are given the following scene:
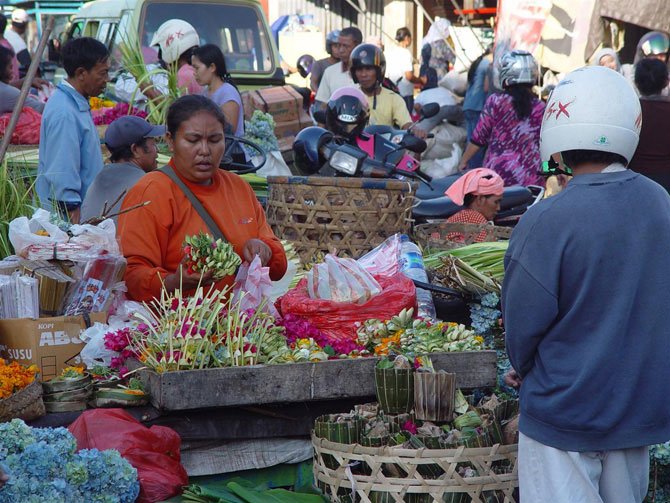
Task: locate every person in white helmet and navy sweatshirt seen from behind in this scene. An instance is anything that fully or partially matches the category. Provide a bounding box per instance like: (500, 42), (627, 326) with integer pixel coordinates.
(502, 66), (670, 503)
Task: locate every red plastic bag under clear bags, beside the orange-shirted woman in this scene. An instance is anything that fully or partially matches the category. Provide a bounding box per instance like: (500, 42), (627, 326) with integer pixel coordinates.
(277, 273), (416, 341)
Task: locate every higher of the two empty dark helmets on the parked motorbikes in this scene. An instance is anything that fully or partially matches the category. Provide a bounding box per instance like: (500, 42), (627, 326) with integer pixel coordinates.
(326, 87), (369, 139)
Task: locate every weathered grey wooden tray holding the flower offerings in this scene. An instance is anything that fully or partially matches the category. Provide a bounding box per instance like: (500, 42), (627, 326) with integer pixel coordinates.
(139, 351), (496, 410)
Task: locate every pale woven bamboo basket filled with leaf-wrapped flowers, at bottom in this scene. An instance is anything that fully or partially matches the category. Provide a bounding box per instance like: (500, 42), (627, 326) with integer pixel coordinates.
(312, 434), (519, 503)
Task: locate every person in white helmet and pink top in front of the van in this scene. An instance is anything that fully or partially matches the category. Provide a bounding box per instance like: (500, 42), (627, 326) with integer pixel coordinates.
(140, 19), (203, 99)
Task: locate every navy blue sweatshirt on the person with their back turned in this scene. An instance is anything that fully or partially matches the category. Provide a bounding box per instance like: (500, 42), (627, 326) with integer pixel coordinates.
(502, 170), (670, 452)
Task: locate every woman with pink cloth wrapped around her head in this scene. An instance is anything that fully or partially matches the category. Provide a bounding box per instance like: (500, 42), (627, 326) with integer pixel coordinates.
(445, 168), (505, 242)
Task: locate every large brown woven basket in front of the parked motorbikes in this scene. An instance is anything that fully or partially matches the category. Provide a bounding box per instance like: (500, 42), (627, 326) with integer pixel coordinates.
(266, 176), (416, 262)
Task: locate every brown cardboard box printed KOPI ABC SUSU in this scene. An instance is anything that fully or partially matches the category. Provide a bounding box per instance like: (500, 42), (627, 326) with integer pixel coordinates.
(0, 313), (107, 381)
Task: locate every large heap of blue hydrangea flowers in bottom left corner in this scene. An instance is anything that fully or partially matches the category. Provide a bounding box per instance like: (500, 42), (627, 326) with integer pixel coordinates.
(0, 419), (140, 503)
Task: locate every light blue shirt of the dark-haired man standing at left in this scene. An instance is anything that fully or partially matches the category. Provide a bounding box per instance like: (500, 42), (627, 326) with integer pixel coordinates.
(36, 83), (103, 210)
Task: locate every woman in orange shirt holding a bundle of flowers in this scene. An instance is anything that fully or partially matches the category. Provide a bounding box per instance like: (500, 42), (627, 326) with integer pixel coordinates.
(119, 95), (287, 301)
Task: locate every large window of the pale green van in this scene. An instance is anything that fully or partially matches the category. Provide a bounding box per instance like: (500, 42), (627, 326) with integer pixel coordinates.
(140, 0), (275, 74)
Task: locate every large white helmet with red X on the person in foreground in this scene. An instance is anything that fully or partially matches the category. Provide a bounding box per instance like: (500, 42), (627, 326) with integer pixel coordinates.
(540, 66), (642, 162)
